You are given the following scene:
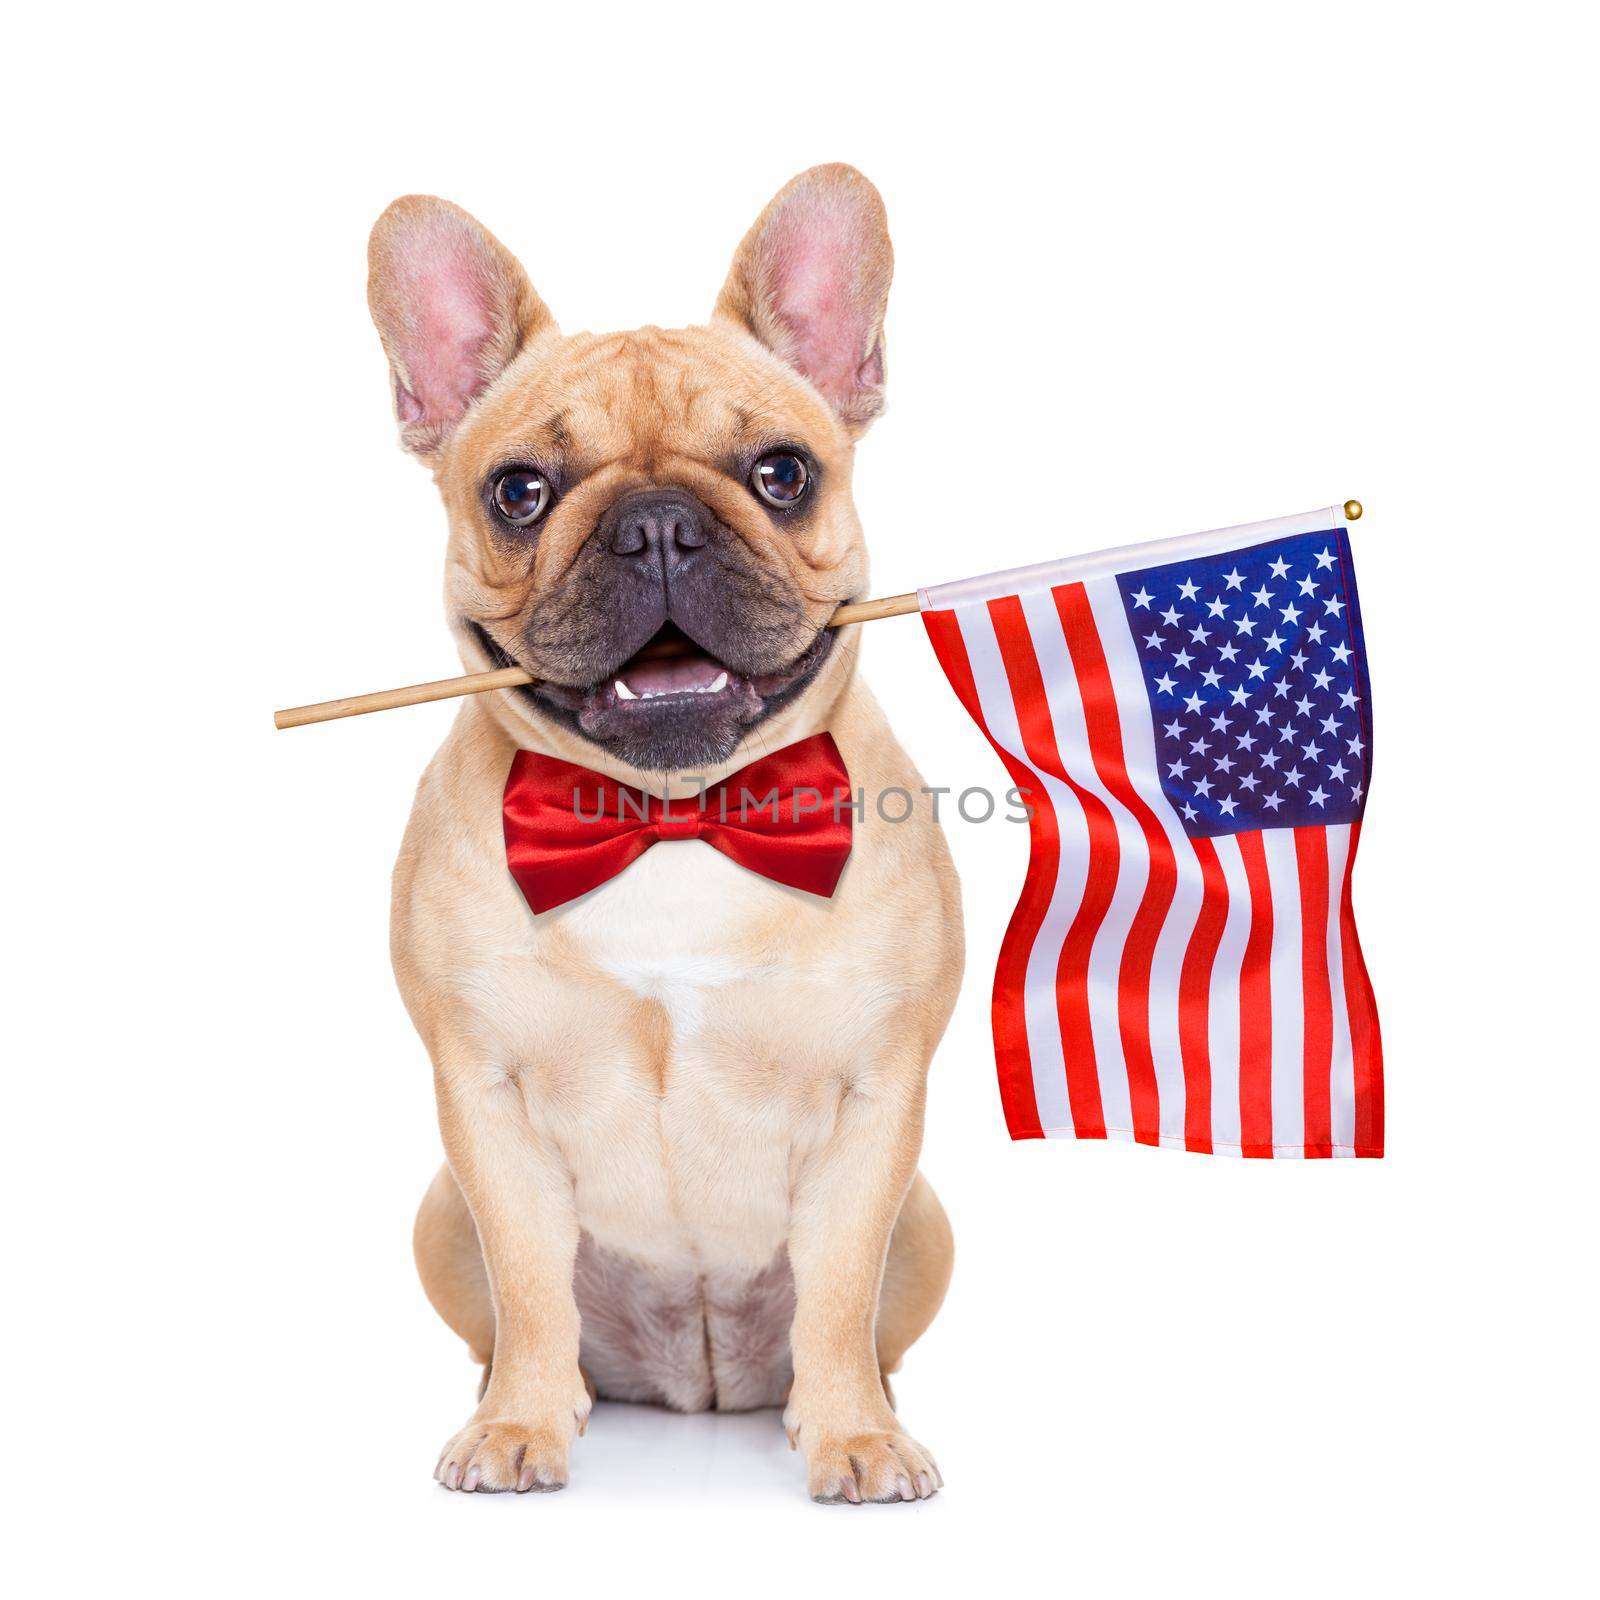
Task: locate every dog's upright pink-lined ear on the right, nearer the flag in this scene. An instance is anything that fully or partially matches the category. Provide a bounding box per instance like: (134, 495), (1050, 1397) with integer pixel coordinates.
(714, 165), (894, 435)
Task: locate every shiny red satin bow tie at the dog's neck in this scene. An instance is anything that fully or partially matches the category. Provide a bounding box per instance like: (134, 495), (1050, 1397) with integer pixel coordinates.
(506, 733), (853, 912)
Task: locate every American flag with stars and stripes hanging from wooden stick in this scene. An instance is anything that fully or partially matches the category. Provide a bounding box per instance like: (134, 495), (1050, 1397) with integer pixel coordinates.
(920, 509), (1384, 1157)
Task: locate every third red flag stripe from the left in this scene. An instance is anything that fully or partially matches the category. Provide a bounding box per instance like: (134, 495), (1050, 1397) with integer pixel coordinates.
(1051, 584), (1178, 1144)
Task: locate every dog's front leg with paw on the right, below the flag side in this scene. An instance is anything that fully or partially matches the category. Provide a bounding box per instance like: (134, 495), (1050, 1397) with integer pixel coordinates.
(784, 1062), (942, 1502)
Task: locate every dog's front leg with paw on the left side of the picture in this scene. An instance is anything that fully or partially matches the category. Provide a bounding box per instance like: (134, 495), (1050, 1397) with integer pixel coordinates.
(434, 1053), (589, 1491)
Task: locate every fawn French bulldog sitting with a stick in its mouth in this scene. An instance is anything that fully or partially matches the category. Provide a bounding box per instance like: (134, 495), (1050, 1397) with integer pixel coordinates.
(368, 165), (962, 1504)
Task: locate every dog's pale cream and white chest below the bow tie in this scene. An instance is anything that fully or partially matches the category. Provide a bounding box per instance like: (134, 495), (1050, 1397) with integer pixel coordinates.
(508, 843), (859, 1272)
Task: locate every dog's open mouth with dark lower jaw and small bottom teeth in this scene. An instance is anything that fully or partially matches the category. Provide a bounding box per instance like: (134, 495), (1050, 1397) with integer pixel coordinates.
(470, 622), (834, 771)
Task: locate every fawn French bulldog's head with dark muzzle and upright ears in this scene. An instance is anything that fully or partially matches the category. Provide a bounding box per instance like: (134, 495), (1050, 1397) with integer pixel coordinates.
(368, 166), (893, 771)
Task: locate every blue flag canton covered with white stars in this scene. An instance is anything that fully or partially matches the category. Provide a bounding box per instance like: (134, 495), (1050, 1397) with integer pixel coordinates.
(1117, 528), (1373, 838)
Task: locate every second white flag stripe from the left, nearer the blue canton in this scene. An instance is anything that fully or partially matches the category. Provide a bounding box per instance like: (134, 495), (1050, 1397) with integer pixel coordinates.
(1022, 592), (1150, 1133)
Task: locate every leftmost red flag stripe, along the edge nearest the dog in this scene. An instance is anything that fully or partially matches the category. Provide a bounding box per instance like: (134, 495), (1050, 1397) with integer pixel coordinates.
(922, 611), (1061, 1139)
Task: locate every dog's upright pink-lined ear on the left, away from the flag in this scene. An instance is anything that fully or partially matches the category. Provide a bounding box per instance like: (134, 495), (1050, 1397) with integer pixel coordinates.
(366, 195), (555, 461)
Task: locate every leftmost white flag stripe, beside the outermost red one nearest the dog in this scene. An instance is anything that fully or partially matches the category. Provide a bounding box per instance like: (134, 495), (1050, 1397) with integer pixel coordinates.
(955, 605), (1090, 1134)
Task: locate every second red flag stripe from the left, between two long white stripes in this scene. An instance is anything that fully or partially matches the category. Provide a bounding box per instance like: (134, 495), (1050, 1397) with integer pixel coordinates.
(989, 595), (1122, 1139)
